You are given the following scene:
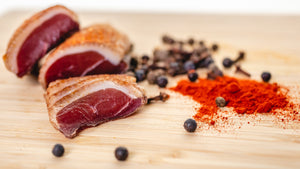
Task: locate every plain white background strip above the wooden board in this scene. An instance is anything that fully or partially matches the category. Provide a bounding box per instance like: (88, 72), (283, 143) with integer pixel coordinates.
(0, 0), (300, 15)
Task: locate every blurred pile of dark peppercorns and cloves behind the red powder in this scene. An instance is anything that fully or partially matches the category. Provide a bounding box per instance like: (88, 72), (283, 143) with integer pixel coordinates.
(127, 35), (223, 88)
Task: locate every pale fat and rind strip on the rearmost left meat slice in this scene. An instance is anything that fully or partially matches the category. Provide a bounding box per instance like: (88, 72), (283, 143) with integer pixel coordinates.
(7, 8), (77, 73)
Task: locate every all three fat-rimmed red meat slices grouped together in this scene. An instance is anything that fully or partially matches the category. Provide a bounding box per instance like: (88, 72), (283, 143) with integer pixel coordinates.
(3, 5), (147, 138)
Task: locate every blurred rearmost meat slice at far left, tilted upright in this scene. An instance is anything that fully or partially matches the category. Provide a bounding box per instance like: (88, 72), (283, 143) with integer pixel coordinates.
(3, 5), (79, 77)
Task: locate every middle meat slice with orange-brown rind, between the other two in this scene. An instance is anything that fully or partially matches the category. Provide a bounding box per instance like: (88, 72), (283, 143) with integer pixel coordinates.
(39, 24), (130, 88)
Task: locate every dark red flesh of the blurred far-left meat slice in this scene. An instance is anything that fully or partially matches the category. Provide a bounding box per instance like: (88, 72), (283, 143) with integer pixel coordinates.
(17, 14), (79, 77)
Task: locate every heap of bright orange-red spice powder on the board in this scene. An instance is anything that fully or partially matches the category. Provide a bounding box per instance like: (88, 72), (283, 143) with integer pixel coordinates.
(170, 76), (294, 125)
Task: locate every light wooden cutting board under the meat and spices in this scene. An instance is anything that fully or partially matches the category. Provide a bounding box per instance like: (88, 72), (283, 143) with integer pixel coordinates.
(0, 11), (300, 169)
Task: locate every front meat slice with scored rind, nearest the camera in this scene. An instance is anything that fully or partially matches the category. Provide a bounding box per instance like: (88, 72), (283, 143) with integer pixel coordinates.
(45, 75), (147, 138)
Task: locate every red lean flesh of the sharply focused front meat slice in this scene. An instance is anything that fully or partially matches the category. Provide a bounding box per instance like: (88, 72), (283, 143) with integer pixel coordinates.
(56, 88), (141, 138)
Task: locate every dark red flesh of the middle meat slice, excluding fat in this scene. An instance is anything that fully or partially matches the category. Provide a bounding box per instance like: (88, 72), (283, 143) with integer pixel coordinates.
(45, 51), (127, 85)
